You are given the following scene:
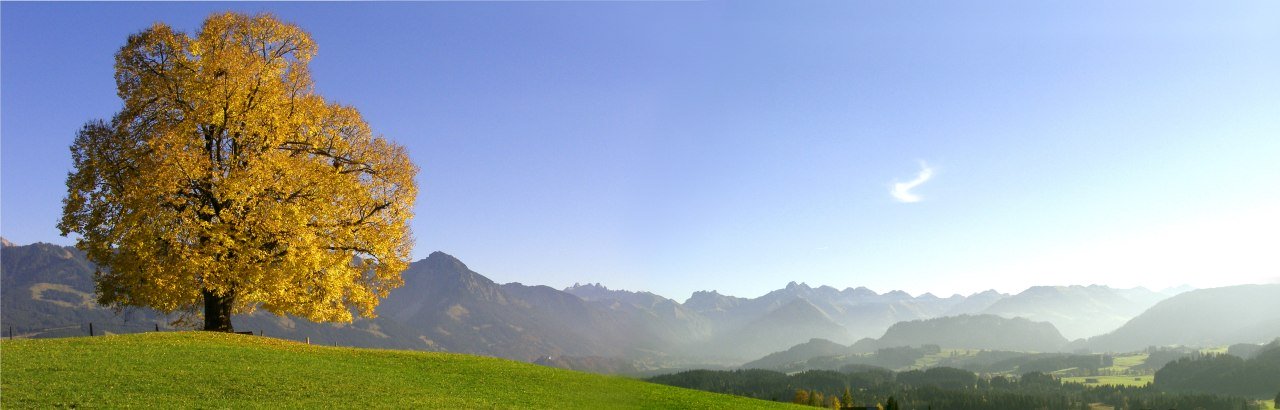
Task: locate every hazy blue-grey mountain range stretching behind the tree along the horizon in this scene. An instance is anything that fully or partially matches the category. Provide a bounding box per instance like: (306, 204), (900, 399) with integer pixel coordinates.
(0, 238), (1280, 370)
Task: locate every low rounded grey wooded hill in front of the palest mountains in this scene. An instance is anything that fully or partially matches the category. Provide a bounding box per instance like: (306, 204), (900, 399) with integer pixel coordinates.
(876, 315), (1068, 351)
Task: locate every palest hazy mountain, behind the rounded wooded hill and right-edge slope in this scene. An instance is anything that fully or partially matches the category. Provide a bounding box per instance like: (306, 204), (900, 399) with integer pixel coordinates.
(982, 284), (1166, 340)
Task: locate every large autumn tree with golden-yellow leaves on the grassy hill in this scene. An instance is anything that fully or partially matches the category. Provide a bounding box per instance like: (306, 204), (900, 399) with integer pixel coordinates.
(58, 13), (417, 332)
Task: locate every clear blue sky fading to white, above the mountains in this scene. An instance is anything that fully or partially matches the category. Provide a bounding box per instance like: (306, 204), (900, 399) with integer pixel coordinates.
(0, 1), (1280, 300)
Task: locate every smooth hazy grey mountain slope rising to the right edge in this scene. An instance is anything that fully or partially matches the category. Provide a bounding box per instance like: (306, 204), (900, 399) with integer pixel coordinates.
(1083, 284), (1280, 352)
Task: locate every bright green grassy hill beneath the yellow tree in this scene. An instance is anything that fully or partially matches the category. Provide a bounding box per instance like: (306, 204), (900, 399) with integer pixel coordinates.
(0, 332), (788, 409)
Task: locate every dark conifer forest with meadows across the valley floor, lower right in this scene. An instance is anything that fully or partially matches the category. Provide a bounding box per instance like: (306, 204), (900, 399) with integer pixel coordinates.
(649, 341), (1280, 410)
